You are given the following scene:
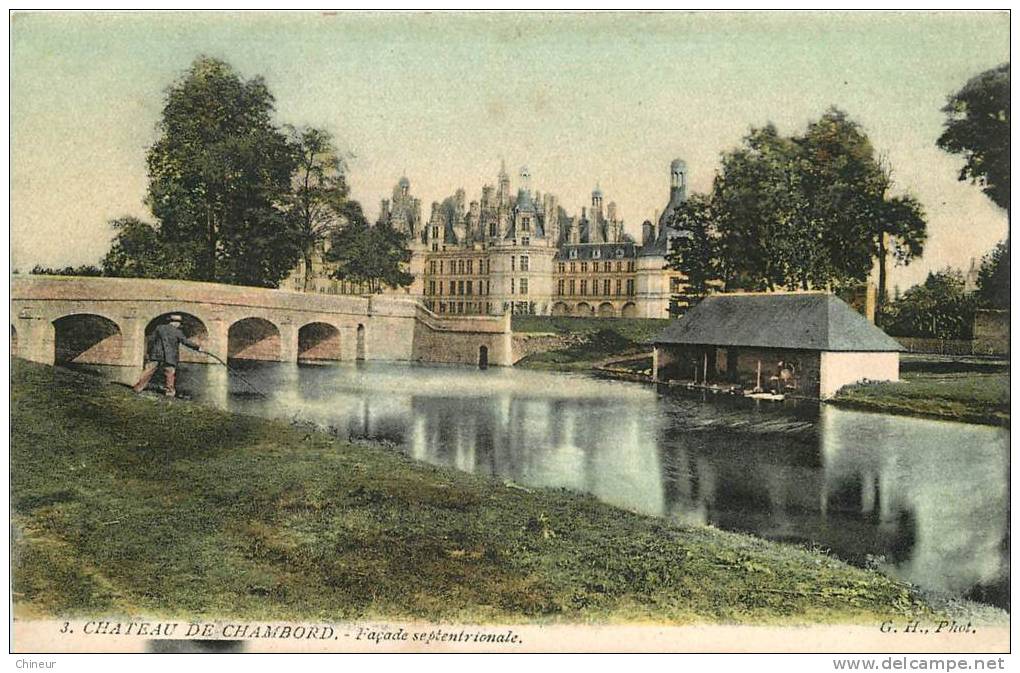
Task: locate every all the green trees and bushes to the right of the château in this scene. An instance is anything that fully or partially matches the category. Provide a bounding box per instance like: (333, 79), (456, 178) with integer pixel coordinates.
(667, 63), (1010, 339)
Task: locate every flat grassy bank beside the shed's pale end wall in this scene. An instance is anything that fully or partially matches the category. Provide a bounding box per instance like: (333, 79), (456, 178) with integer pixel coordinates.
(833, 355), (1010, 425)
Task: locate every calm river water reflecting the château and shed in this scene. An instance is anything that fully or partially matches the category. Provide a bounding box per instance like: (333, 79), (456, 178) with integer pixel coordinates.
(163, 363), (1010, 609)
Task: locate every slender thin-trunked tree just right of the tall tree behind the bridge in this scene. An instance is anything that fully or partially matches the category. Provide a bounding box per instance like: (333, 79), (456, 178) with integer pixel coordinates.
(288, 126), (350, 292)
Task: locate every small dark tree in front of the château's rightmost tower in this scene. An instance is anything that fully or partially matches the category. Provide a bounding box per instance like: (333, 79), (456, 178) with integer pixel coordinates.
(666, 194), (720, 308)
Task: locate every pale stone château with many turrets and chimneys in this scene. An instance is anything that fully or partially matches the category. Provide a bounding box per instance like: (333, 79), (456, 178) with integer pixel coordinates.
(284, 159), (686, 318)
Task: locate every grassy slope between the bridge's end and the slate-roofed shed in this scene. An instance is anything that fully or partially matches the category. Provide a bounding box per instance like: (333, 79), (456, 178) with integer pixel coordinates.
(512, 316), (669, 371)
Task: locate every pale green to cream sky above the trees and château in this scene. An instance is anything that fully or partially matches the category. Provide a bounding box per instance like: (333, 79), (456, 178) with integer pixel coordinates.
(10, 11), (1010, 289)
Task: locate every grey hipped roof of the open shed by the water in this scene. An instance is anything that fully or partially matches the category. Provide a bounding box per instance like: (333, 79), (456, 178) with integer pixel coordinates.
(653, 293), (903, 352)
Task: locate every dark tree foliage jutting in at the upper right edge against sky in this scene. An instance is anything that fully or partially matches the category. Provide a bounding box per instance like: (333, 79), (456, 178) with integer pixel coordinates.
(935, 63), (1010, 212)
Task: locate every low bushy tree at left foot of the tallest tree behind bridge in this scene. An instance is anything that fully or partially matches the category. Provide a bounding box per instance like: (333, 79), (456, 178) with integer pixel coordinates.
(101, 216), (198, 278)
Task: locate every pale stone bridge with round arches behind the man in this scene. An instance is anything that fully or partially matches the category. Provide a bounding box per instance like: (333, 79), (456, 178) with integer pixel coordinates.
(10, 275), (512, 379)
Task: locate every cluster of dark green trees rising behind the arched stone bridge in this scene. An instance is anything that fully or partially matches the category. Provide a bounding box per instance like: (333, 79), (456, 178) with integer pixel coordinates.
(35, 57), (412, 290)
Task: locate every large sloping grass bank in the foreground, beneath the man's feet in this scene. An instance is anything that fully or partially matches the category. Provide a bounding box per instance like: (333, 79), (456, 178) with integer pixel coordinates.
(10, 361), (928, 623)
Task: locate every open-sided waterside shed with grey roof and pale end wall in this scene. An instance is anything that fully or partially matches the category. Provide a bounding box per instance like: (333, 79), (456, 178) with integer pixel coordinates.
(653, 293), (903, 398)
